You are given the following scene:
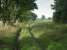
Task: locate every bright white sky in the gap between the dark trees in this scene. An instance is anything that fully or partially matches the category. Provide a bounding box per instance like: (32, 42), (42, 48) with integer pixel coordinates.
(34, 0), (54, 18)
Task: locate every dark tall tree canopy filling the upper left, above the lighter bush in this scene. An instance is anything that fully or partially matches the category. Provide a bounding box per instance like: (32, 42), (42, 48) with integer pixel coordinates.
(0, 0), (37, 23)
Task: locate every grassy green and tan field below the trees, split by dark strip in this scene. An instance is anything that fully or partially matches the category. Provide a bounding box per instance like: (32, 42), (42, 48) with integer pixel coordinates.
(0, 20), (67, 50)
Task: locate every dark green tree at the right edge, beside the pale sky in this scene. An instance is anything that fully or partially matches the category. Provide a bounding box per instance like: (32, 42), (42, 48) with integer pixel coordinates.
(52, 0), (67, 23)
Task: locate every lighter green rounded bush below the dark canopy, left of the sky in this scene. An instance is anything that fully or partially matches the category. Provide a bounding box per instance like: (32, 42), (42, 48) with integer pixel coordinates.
(19, 11), (37, 22)
